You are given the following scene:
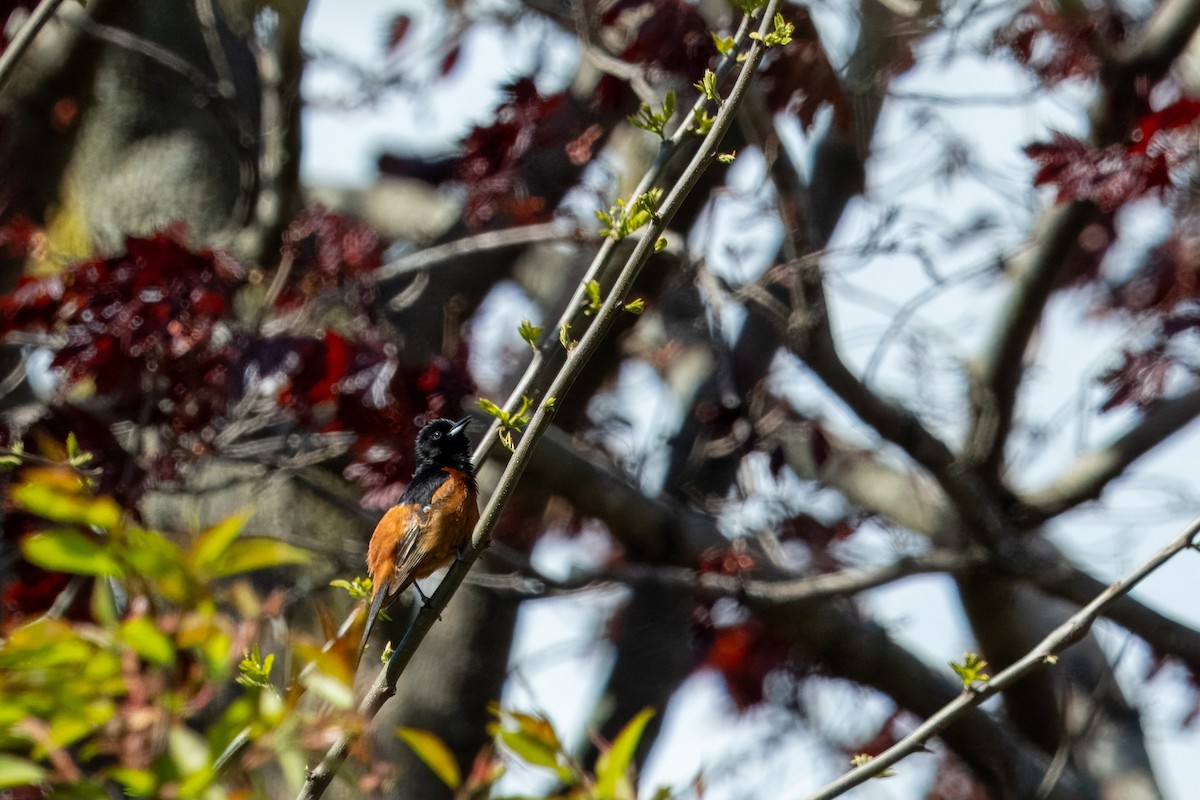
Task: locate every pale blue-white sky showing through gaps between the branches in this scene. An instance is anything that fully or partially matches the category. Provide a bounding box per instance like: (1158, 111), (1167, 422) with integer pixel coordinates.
(302, 0), (1200, 800)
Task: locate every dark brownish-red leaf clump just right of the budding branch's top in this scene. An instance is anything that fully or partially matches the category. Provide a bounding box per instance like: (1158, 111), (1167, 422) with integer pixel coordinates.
(762, 8), (853, 132)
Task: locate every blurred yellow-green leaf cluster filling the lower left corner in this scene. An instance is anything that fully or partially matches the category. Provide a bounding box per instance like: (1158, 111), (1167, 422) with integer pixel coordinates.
(0, 453), (333, 799)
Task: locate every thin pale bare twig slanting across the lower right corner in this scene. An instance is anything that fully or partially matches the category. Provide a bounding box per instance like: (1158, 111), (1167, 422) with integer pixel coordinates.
(809, 517), (1200, 800)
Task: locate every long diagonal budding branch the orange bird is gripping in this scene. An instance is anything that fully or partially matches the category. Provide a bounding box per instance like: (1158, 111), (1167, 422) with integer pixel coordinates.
(298, 0), (780, 800)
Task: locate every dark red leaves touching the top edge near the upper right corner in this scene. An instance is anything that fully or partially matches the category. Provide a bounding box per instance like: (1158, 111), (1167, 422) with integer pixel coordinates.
(995, 0), (1130, 85)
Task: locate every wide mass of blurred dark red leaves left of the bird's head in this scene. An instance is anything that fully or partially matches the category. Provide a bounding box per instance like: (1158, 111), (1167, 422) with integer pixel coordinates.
(0, 209), (473, 503)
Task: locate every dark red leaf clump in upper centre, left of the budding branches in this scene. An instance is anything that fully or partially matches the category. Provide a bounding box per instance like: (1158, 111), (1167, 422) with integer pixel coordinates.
(458, 78), (571, 229)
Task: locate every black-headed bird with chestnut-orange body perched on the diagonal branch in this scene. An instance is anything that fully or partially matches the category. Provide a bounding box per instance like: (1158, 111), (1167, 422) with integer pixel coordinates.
(355, 417), (479, 663)
